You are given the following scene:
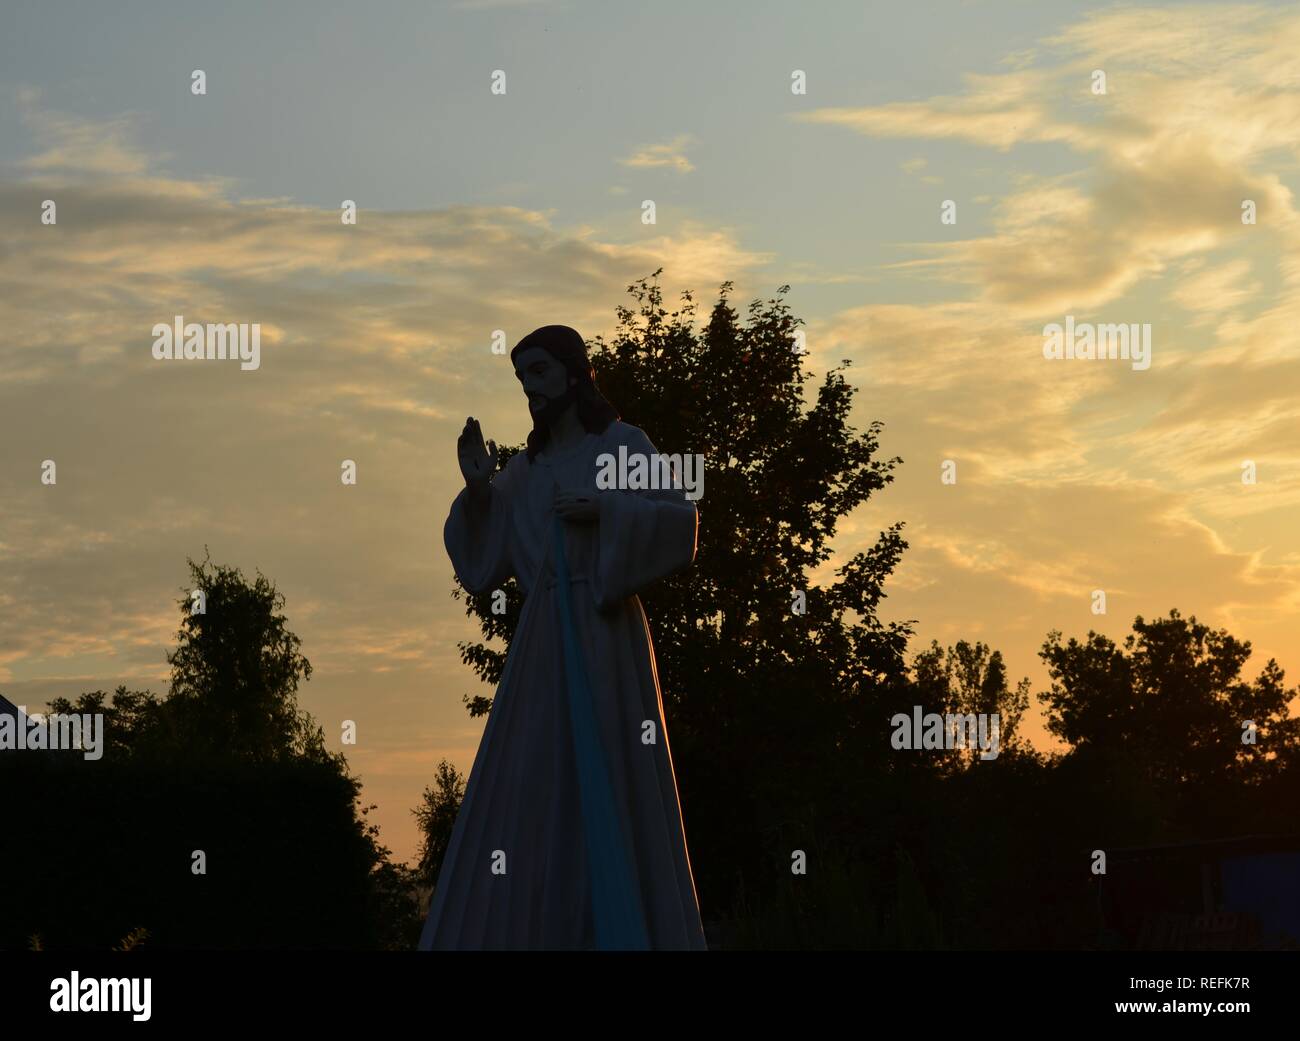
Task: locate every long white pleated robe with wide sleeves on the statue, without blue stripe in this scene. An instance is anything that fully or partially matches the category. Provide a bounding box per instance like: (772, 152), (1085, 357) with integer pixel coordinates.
(420, 421), (707, 950)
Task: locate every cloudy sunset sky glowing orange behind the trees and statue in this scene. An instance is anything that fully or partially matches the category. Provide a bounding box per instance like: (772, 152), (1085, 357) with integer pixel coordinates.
(0, 0), (1300, 859)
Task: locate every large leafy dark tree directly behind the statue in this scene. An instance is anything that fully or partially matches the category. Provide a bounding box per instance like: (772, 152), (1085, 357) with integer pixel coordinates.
(452, 272), (911, 903)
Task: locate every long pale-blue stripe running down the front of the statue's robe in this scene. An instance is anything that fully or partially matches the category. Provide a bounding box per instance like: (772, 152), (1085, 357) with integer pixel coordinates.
(555, 517), (650, 950)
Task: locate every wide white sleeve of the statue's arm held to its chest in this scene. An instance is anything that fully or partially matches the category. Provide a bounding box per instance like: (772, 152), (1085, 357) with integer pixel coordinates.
(592, 428), (699, 611)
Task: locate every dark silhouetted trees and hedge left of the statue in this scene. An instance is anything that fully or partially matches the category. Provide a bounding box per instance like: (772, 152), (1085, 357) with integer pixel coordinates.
(0, 551), (419, 950)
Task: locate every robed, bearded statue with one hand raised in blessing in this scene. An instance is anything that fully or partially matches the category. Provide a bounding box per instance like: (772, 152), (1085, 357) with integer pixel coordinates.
(420, 325), (706, 950)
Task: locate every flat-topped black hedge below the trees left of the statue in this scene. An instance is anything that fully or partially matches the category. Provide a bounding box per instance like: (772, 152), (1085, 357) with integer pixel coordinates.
(0, 752), (400, 950)
